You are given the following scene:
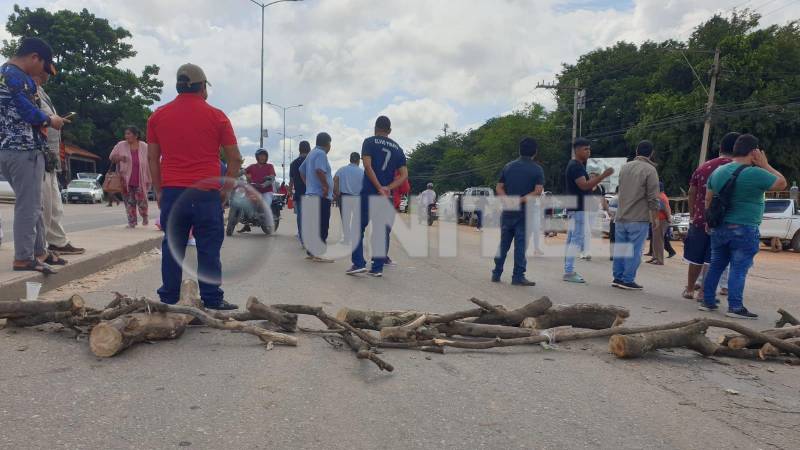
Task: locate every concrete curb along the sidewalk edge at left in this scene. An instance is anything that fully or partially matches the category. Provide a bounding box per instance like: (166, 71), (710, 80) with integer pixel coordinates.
(0, 235), (162, 301)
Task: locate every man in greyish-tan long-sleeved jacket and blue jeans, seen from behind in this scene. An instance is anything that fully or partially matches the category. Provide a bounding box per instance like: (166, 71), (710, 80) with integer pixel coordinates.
(611, 141), (659, 290)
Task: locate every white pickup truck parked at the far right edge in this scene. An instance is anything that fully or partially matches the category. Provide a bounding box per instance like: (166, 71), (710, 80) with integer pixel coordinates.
(758, 198), (800, 252)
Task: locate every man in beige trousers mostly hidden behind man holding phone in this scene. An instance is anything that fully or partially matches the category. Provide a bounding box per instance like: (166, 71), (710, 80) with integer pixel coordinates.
(33, 73), (85, 255)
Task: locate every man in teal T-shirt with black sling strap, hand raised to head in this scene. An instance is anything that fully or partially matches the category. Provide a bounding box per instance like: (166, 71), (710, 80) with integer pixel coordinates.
(699, 134), (786, 319)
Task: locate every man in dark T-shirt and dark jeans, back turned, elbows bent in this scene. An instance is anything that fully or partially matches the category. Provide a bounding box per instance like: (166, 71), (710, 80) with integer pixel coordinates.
(492, 137), (544, 286)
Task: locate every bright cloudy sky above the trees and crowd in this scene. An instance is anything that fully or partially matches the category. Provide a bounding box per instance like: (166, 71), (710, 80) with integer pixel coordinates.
(0, 0), (800, 176)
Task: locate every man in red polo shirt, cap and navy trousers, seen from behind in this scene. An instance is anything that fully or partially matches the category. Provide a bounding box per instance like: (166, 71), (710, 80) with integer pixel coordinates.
(147, 64), (242, 309)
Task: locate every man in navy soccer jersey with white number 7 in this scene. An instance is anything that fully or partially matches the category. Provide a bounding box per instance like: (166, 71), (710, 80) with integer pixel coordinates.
(346, 116), (408, 277)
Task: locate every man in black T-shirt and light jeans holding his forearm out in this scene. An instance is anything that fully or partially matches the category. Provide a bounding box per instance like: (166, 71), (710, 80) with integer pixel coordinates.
(563, 138), (614, 283)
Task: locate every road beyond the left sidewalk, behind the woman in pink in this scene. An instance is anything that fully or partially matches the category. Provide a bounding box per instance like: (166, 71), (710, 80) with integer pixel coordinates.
(0, 202), (158, 246)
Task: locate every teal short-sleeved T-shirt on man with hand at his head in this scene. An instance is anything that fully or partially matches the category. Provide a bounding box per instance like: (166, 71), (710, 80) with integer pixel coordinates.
(708, 162), (778, 227)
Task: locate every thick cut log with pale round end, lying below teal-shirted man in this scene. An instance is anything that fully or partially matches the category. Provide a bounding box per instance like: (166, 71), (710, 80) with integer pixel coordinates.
(608, 322), (718, 358)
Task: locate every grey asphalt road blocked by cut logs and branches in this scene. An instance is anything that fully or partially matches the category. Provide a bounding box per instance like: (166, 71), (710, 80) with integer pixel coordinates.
(0, 212), (800, 449)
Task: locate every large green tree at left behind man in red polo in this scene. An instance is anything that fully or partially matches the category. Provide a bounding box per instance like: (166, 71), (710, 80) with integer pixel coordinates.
(1, 5), (163, 171)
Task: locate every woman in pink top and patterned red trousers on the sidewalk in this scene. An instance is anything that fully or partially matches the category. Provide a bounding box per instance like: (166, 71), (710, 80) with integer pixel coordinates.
(109, 126), (152, 228)
